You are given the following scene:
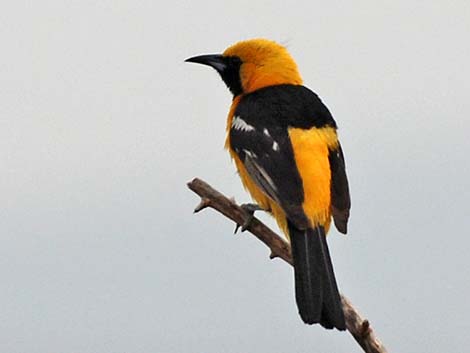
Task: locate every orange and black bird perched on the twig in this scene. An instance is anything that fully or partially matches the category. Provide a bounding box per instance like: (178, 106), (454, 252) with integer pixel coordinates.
(185, 38), (351, 331)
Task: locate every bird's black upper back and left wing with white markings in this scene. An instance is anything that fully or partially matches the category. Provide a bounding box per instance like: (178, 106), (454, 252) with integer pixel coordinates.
(230, 85), (336, 229)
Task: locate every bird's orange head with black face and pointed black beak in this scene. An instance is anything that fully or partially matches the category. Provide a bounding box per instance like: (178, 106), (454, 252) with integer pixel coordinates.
(186, 39), (302, 96)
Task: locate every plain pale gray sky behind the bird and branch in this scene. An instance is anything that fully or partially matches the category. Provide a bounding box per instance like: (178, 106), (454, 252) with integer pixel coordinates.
(0, 0), (470, 353)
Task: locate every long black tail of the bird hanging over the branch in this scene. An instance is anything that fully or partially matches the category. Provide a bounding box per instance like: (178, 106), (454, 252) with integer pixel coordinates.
(289, 224), (346, 330)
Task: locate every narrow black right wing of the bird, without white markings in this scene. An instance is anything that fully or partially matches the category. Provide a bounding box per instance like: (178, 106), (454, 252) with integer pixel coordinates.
(328, 145), (351, 234)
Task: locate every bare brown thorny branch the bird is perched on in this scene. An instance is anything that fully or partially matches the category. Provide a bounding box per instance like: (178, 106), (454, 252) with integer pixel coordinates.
(188, 178), (387, 353)
